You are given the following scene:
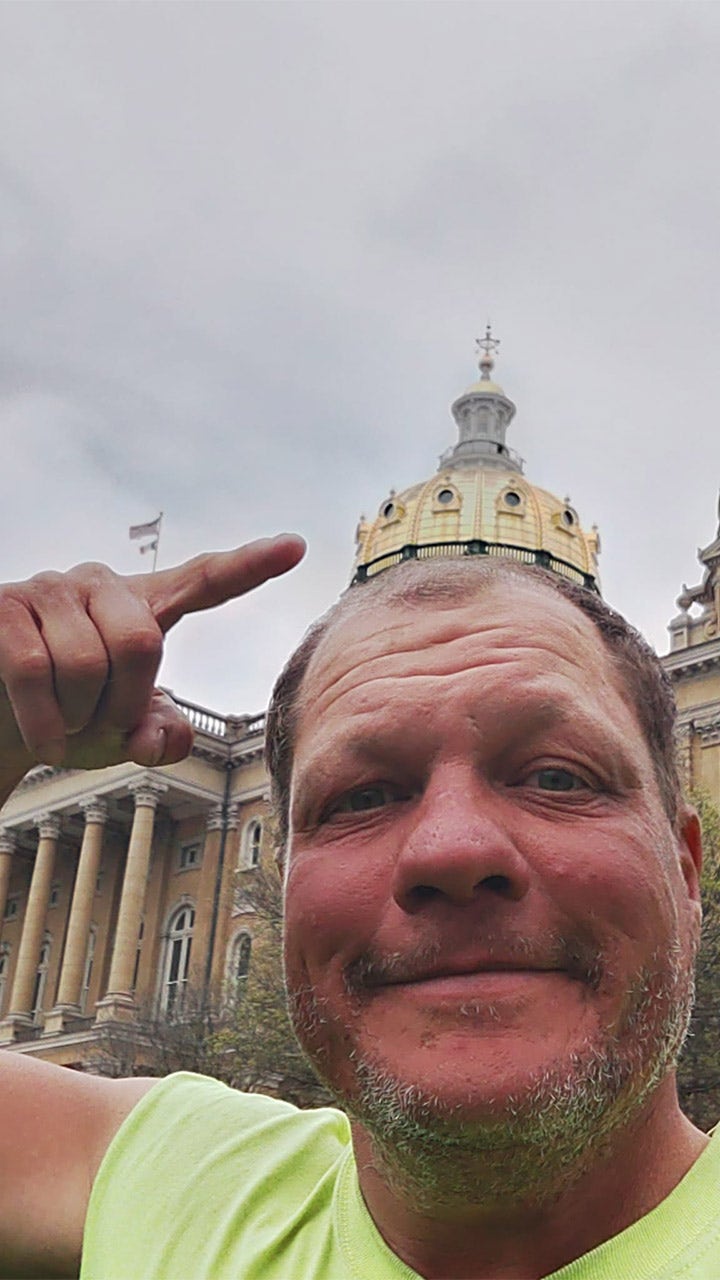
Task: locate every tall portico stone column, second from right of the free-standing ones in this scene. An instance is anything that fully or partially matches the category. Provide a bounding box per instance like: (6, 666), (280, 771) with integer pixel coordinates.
(45, 796), (108, 1036)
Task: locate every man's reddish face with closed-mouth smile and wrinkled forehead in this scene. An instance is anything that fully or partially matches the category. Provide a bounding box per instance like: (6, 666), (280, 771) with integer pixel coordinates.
(286, 582), (698, 1120)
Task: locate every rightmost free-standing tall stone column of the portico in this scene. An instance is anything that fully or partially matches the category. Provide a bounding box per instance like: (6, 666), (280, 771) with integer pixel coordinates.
(97, 781), (168, 1023)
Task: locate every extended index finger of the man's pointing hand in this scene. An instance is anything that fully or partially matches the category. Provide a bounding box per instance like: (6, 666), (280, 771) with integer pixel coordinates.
(133, 534), (305, 632)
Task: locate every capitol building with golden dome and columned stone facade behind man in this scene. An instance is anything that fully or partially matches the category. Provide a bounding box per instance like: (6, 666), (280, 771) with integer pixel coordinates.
(0, 329), (720, 1069)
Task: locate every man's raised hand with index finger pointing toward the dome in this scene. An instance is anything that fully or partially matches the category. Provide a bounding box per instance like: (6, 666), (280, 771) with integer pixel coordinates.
(0, 534), (305, 785)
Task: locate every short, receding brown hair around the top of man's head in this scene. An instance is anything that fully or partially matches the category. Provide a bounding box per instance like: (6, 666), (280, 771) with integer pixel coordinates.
(265, 557), (682, 851)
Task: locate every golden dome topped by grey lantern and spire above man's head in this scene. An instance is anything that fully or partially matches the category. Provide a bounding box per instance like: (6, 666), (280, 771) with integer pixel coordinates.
(352, 326), (600, 590)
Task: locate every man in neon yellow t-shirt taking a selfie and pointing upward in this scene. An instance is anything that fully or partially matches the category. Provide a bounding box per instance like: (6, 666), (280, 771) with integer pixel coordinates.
(0, 536), (720, 1280)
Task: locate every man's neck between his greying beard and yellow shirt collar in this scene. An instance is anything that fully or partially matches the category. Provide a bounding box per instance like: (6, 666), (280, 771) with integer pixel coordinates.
(354, 1078), (708, 1280)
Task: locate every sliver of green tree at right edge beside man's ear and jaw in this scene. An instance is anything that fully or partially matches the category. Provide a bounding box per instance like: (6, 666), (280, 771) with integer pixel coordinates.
(678, 788), (720, 1129)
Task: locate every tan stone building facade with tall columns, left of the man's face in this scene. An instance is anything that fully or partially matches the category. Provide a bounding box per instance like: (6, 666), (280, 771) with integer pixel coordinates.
(0, 701), (273, 1068)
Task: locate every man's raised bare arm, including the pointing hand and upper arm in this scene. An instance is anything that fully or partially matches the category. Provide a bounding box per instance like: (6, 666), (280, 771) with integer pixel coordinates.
(0, 535), (304, 1280)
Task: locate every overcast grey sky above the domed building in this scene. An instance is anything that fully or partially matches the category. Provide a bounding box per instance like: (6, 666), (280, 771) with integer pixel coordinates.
(0, 0), (720, 713)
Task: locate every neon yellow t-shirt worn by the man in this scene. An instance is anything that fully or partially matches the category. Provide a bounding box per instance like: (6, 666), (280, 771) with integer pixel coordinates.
(81, 1073), (720, 1280)
